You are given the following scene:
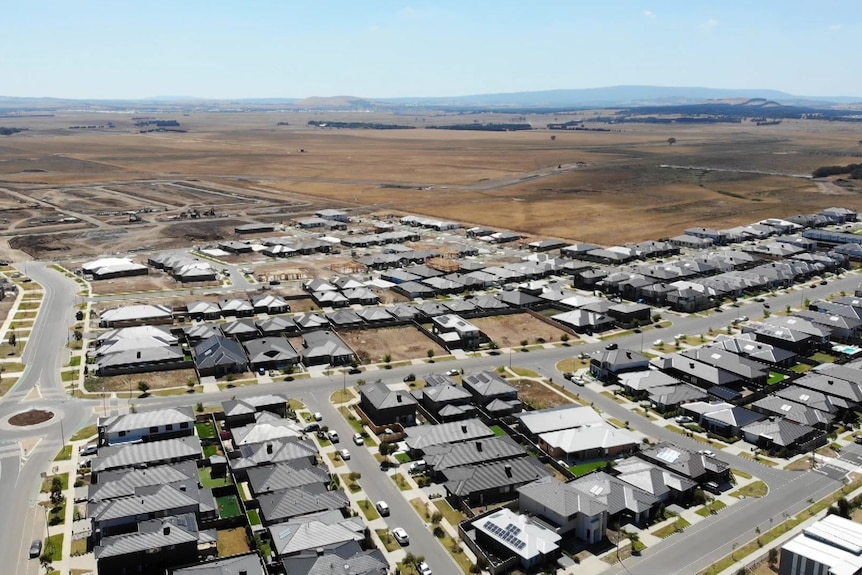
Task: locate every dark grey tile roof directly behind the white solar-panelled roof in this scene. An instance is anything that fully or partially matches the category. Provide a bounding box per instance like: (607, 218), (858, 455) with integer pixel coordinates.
(443, 456), (553, 497)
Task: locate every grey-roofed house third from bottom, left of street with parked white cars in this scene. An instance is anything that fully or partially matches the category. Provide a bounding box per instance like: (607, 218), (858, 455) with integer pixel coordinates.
(256, 486), (350, 526)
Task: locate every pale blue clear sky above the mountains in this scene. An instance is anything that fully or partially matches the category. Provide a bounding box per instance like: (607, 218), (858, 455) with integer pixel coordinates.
(0, 0), (862, 99)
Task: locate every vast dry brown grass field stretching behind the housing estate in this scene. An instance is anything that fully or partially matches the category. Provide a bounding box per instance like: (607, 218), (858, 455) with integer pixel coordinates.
(0, 112), (862, 259)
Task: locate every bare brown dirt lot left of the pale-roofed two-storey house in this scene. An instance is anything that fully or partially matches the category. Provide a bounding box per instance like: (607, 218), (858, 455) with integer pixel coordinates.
(339, 326), (447, 363)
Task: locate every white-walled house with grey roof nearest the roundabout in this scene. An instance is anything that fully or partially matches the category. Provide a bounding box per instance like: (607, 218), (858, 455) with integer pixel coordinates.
(97, 407), (195, 445)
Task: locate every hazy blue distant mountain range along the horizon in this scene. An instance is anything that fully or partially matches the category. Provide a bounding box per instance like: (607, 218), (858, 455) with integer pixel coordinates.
(0, 86), (862, 113)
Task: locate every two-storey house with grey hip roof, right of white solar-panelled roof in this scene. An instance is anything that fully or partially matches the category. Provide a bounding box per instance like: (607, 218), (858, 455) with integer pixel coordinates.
(518, 476), (608, 545)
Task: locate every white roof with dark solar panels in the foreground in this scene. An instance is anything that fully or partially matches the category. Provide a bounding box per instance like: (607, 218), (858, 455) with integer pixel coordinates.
(473, 508), (562, 561)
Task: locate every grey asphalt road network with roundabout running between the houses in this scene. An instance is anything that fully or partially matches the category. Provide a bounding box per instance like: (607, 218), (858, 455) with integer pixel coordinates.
(0, 263), (862, 574)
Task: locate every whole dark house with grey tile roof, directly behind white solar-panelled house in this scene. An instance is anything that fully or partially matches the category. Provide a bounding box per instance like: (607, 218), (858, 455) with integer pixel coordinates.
(439, 456), (553, 507)
